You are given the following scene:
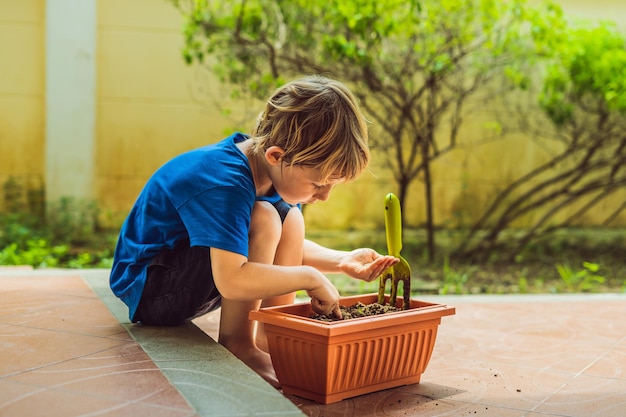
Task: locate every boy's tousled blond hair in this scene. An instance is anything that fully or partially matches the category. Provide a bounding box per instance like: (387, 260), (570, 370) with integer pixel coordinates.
(252, 76), (370, 181)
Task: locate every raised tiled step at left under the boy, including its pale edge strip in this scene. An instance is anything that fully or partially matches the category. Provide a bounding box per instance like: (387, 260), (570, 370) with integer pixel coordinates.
(0, 269), (302, 417)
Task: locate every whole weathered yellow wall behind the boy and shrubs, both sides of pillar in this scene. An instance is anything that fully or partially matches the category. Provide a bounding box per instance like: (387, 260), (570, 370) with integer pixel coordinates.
(0, 0), (626, 228)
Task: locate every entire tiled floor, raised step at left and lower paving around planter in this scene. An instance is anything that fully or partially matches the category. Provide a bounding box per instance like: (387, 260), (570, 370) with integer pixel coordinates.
(0, 269), (626, 417)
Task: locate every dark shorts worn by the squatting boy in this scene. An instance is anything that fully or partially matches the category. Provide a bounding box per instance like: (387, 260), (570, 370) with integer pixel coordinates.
(133, 200), (292, 326)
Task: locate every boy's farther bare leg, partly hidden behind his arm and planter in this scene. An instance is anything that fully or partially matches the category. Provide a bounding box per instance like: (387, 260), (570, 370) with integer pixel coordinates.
(256, 207), (304, 352)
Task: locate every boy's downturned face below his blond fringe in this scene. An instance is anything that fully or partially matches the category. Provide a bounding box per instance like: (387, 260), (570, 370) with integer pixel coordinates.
(272, 162), (345, 204)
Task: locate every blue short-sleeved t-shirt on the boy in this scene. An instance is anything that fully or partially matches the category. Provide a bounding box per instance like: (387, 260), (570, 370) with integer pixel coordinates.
(110, 133), (258, 319)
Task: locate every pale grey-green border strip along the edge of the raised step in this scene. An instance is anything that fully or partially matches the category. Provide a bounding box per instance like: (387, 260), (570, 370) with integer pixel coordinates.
(81, 270), (303, 417)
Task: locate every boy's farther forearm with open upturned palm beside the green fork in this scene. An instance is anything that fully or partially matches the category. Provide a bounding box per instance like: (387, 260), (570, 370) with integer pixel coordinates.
(302, 239), (399, 282)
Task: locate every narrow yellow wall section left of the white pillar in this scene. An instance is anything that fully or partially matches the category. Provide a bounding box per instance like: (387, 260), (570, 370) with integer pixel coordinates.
(0, 0), (45, 209)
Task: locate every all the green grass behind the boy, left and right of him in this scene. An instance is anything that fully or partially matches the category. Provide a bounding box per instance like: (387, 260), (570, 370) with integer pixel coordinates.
(0, 210), (626, 295)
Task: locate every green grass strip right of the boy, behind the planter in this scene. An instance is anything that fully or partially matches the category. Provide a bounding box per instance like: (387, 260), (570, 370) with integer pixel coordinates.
(307, 229), (626, 295)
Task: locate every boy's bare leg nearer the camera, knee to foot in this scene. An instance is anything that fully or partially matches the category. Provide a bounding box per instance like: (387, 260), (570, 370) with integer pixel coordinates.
(219, 202), (281, 388)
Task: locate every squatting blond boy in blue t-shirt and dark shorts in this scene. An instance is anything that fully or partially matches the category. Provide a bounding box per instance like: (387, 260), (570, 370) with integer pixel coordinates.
(110, 76), (398, 386)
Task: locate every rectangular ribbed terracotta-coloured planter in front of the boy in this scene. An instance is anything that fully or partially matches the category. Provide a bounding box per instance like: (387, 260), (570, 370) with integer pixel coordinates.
(250, 294), (455, 404)
